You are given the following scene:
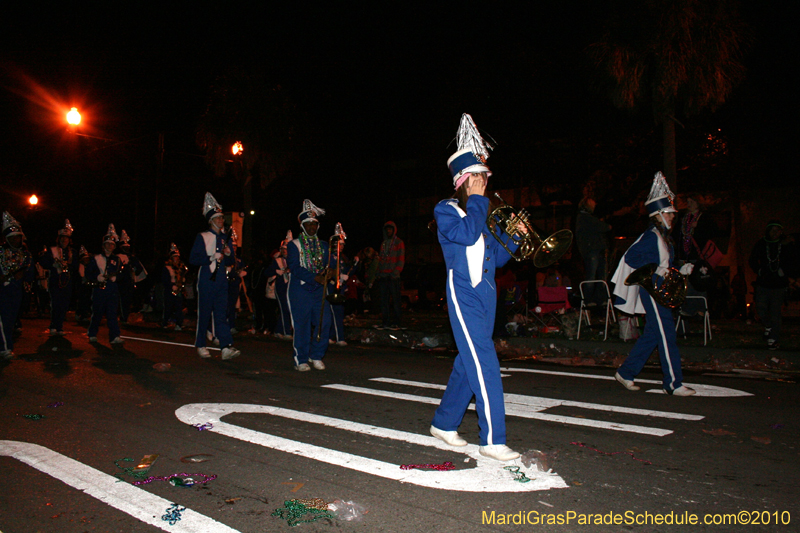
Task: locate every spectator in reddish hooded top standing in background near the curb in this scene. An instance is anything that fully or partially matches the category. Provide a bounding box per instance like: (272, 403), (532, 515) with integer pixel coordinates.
(377, 220), (406, 330)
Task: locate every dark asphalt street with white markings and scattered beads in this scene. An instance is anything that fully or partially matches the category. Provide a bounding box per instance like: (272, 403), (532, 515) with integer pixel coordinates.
(0, 320), (800, 533)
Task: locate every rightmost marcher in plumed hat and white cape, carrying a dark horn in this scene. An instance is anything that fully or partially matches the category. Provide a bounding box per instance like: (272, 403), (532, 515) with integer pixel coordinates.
(611, 172), (695, 396)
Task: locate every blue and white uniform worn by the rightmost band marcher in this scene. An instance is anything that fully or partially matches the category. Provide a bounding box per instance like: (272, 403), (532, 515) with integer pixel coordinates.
(614, 226), (683, 394)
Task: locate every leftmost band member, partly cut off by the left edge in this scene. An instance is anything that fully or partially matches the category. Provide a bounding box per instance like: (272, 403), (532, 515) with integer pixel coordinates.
(0, 212), (36, 359)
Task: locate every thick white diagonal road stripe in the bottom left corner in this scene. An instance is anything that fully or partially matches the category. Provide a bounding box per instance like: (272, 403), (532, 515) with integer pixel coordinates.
(0, 440), (238, 533)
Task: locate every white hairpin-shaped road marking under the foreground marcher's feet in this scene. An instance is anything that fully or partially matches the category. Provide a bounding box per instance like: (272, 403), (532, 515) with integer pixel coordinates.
(175, 403), (567, 492)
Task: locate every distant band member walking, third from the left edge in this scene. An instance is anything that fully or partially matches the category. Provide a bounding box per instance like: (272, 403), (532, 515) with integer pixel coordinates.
(86, 224), (125, 344)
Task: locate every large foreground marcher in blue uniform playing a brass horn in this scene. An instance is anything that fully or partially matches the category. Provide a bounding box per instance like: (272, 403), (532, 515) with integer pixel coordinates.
(430, 114), (519, 461)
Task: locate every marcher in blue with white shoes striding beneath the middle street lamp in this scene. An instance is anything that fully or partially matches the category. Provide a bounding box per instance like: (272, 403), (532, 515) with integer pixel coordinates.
(189, 192), (241, 359)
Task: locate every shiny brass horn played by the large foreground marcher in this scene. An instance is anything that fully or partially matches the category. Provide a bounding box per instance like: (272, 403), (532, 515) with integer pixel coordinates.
(486, 193), (572, 268)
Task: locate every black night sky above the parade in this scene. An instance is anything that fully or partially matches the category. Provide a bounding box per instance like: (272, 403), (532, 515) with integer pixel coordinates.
(0, 0), (798, 260)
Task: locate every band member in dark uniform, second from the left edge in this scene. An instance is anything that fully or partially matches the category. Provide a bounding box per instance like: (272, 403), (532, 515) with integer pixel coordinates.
(39, 220), (79, 336)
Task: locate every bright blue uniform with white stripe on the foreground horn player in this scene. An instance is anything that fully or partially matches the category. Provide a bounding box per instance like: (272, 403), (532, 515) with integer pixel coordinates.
(433, 195), (516, 446)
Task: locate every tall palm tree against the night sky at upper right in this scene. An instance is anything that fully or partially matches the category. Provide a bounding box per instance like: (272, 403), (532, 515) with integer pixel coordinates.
(588, 0), (750, 189)
